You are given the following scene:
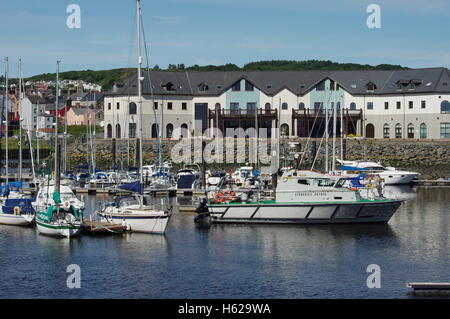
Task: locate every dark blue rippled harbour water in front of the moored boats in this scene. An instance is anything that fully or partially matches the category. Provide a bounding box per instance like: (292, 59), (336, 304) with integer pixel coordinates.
(0, 187), (450, 298)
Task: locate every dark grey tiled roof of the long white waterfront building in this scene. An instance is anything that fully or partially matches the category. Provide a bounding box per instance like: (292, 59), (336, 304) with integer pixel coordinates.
(105, 68), (450, 96)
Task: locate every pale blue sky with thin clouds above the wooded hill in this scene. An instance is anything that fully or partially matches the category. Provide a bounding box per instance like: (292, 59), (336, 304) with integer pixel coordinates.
(0, 0), (450, 76)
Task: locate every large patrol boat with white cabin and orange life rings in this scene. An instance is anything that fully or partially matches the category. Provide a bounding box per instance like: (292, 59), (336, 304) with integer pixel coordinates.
(197, 170), (402, 224)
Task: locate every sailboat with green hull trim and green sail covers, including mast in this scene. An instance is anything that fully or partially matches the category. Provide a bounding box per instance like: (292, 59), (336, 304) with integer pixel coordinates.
(36, 61), (82, 237)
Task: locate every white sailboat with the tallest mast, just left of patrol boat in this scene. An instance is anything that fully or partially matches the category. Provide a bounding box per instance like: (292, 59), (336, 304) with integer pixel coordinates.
(98, 0), (171, 234)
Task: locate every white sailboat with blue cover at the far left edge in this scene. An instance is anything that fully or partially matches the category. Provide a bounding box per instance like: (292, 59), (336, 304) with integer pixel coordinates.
(0, 59), (35, 226)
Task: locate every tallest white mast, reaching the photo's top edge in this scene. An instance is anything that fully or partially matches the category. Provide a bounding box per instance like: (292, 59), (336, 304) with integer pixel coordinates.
(136, 0), (144, 195)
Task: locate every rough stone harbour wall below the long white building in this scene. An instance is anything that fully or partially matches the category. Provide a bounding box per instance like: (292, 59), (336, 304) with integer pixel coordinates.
(60, 138), (450, 179)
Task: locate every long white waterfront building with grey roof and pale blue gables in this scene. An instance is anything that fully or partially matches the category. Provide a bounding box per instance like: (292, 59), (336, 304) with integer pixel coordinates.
(104, 68), (450, 139)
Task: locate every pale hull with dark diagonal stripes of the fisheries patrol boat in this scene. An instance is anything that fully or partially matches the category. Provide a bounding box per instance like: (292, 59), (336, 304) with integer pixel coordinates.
(208, 200), (402, 224)
